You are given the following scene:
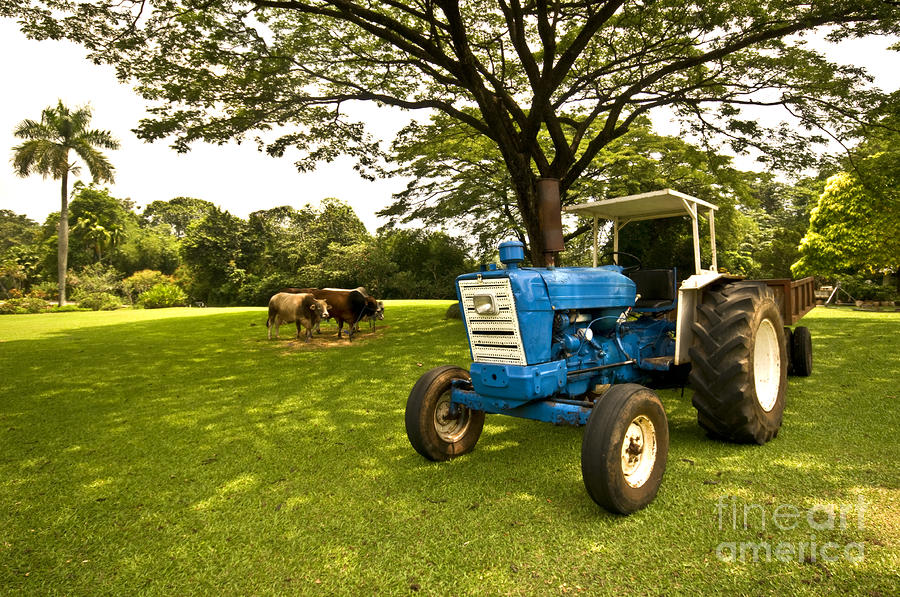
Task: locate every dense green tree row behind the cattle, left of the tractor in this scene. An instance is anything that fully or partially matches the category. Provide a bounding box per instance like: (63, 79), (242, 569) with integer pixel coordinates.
(0, 190), (473, 312)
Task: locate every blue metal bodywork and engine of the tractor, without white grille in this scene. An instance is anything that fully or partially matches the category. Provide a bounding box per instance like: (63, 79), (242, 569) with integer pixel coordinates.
(452, 242), (675, 425)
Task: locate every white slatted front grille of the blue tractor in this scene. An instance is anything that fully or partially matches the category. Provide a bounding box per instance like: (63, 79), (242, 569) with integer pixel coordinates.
(459, 278), (528, 365)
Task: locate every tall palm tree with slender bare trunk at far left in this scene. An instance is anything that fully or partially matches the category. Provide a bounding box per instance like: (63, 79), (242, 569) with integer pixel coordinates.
(12, 100), (119, 306)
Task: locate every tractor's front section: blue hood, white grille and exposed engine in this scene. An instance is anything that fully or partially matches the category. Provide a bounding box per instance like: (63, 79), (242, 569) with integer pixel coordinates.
(457, 241), (675, 412)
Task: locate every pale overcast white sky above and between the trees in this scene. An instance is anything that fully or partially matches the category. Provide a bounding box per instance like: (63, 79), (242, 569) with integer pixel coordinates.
(0, 19), (900, 232)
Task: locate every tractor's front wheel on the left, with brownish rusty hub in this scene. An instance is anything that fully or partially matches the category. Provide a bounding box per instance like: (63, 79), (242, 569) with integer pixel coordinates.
(406, 365), (484, 461)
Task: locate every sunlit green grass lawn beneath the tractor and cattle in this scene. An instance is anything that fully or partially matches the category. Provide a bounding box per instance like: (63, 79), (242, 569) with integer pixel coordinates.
(0, 301), (900, 595)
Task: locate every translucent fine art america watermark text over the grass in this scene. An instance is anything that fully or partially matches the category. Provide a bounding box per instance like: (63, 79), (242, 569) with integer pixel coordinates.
(716, 495), (866, 562)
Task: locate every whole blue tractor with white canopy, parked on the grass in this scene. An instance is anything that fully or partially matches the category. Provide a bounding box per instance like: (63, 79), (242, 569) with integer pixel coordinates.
(406, 189), (812, 514)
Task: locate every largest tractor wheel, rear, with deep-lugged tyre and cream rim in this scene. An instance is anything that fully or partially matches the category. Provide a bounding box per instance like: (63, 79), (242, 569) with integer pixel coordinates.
(690, 281), (788, 444)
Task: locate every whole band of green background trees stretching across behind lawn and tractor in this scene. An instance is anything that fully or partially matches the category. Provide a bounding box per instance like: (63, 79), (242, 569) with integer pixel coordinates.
(0, 99), (900, 308)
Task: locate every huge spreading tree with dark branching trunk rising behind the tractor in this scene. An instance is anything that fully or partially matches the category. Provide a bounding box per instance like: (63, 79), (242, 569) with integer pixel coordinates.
(0, 0), (900, 263)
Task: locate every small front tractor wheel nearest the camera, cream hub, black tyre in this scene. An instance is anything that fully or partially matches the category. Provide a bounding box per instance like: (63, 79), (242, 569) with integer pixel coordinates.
(581, 384), (669, 514)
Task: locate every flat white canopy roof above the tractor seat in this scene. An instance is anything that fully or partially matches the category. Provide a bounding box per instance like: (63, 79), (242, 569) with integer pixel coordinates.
(565, 189), (718, 222)
